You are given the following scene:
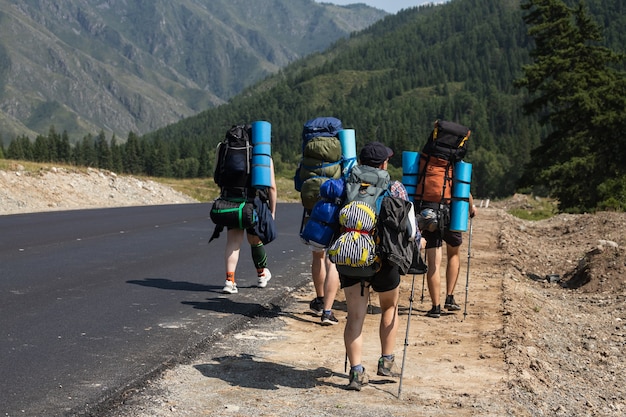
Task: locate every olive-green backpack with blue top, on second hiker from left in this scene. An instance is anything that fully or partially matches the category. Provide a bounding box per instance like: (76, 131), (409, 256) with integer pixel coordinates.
(294, 117), (343, 210)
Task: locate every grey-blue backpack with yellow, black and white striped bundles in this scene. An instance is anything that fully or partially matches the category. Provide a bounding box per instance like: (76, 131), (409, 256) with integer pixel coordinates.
(328, 165), (391, 277)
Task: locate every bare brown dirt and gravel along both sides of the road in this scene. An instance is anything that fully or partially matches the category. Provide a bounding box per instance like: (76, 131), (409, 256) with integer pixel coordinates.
(0, 165), (626, 417)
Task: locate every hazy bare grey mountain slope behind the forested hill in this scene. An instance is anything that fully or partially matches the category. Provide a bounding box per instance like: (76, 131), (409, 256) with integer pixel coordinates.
(0, 0), (385, 141)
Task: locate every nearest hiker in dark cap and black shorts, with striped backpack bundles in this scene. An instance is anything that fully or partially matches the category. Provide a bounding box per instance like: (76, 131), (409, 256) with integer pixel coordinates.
(328, 142), (421, 391)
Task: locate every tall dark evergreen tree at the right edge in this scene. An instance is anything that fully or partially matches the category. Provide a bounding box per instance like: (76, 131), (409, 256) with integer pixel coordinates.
(516, 0), (626, 212)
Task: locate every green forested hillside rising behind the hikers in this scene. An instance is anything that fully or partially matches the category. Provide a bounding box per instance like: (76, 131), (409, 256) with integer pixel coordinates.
(4, 0), (626, 202)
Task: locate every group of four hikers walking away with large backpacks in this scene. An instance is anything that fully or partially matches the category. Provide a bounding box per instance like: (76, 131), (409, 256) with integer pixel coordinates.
(211, 117), (476, 391)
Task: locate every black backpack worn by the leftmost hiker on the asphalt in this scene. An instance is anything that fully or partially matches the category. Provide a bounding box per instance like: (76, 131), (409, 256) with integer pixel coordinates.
(213, 125), (252, 198)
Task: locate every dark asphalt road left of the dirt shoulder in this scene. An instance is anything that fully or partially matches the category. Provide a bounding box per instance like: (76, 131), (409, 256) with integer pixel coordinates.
(0, 203), (310, 417)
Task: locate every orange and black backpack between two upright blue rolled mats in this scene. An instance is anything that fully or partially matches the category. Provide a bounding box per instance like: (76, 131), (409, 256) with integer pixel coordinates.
(415, 120), (471, 233)
